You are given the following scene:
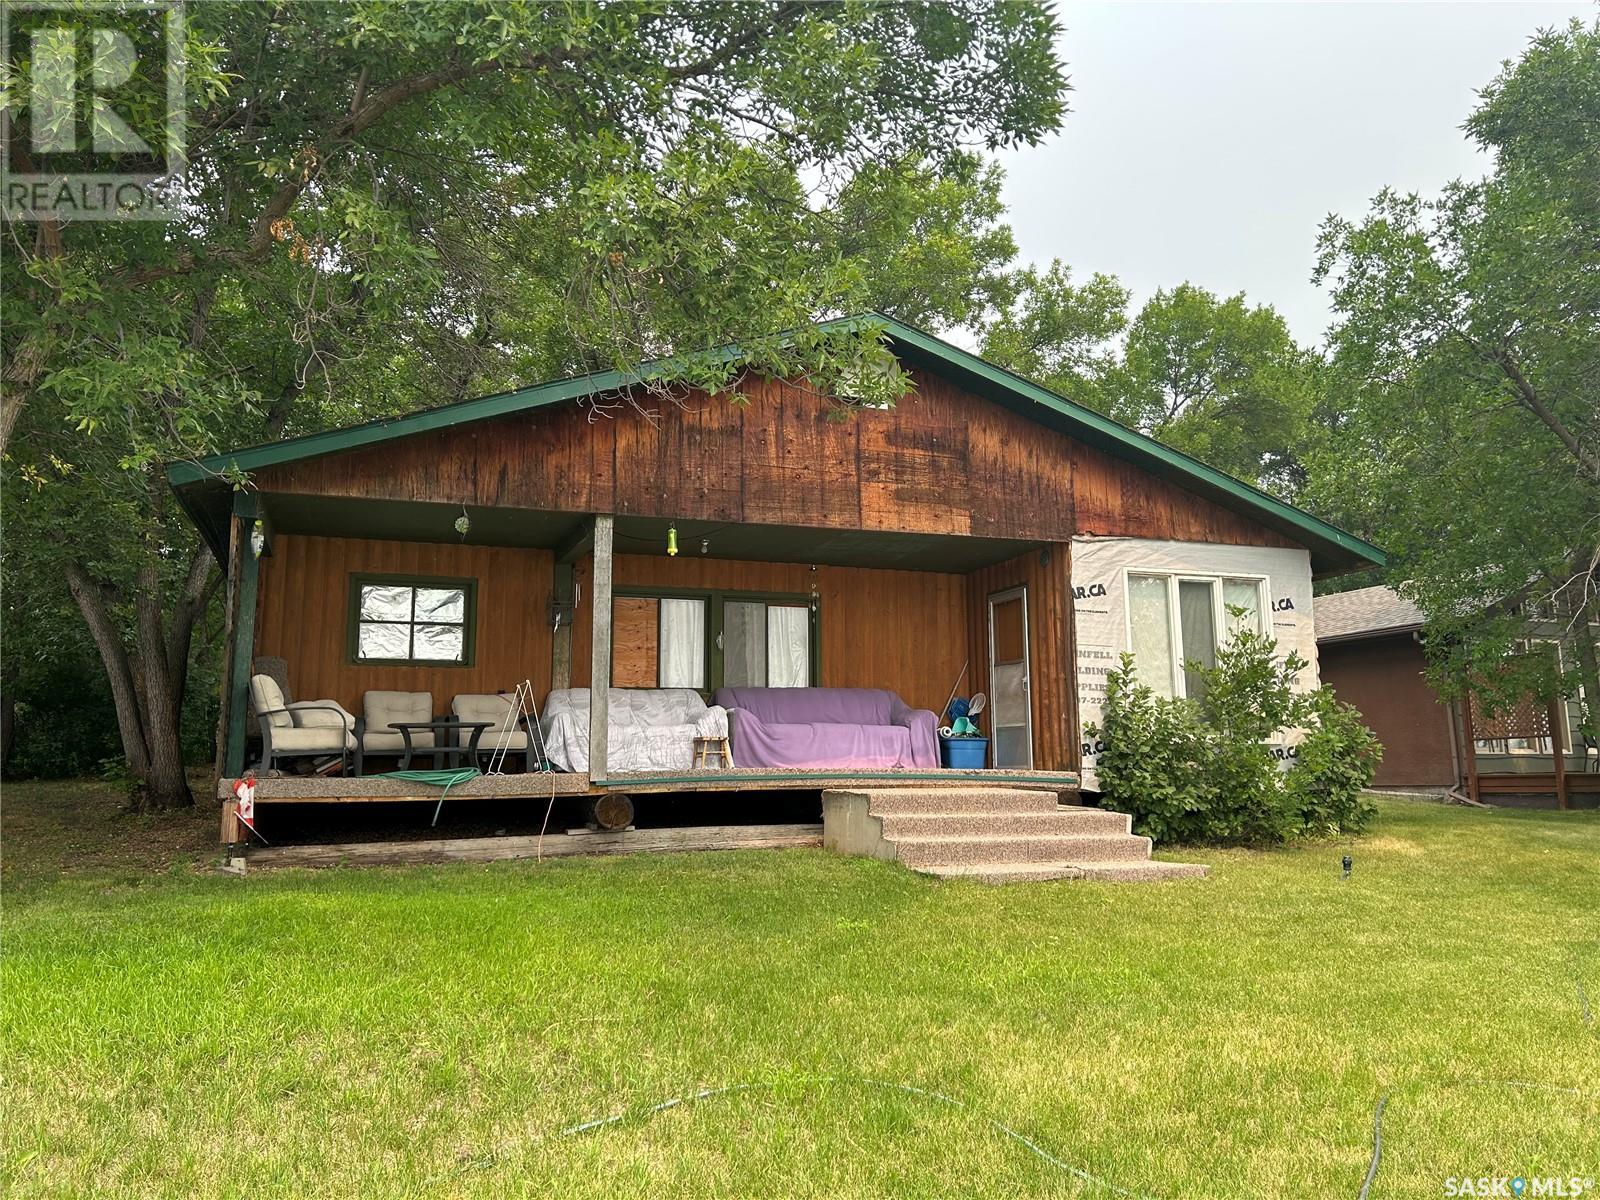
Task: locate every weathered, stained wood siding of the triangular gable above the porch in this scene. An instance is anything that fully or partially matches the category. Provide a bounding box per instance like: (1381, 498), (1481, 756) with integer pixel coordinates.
(256, 371), (1293, 546)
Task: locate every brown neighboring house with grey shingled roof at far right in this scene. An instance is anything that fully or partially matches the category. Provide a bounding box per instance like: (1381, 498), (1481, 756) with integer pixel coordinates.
(1315, 587), (1600, 809)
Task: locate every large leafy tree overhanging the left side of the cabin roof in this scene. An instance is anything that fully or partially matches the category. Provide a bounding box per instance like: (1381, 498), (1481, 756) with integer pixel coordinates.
(0, 0), (1066, 805)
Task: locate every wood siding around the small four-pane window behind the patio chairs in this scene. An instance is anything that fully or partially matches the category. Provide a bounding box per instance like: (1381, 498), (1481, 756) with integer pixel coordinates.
(256, 534), (550, 715)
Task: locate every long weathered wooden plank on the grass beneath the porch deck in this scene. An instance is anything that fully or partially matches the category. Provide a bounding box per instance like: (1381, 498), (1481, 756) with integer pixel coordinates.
(250, 824), (822, 867)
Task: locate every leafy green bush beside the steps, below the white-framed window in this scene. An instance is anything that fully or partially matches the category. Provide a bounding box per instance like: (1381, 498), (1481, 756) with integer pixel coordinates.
(1086, 629), (1381, 843)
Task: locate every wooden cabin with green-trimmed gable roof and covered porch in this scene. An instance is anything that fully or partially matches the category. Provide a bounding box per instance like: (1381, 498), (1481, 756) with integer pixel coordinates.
(170, 320), (1382, 844)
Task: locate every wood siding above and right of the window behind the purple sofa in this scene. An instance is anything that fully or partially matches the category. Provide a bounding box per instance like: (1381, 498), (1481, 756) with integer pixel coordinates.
(573, 554), (966, 723)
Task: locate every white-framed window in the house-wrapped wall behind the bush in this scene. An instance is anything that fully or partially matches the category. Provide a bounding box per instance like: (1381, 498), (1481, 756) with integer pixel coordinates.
(1126, 570), (1267, 699)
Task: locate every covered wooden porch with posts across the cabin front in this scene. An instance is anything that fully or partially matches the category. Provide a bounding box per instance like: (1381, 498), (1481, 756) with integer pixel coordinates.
(206, 491), (1078, 842)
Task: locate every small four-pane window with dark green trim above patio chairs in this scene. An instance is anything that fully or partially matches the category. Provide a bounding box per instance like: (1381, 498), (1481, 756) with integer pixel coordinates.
(349, 574), (478, 667)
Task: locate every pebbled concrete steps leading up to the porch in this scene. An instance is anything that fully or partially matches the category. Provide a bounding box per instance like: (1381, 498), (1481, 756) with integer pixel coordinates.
(822, 786), (1206, 883)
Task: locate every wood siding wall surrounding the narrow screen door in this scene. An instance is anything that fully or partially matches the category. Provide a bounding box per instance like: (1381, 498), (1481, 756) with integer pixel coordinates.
(957, 542), (1083, 771)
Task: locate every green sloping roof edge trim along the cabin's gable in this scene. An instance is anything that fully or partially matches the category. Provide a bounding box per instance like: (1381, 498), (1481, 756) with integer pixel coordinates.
(166, 314), (1387, 574)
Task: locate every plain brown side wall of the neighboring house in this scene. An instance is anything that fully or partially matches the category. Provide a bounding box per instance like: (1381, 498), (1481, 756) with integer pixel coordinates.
(1317, 634), (1456, 787)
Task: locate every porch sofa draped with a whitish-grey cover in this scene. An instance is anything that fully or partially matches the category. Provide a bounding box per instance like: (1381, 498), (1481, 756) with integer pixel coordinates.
(539, 688), (728, 771)
